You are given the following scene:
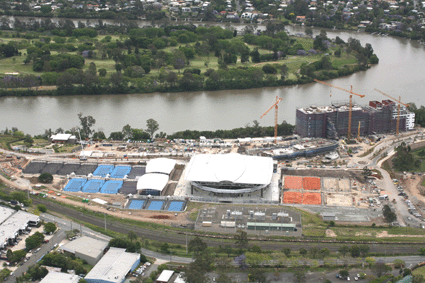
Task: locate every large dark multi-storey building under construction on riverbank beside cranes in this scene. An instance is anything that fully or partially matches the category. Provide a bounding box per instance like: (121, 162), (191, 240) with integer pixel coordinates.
(295, 100), (415, 139)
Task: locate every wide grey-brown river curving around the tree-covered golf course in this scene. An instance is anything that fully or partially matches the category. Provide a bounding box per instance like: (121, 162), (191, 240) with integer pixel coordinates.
(0, 22), (425, 135)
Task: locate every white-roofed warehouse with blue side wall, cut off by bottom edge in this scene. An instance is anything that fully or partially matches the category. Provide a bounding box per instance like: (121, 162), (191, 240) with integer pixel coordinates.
(84, 248), (140, 283)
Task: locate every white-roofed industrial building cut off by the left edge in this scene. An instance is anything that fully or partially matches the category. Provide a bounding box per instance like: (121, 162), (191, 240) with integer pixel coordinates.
(0, 206), (40, 248)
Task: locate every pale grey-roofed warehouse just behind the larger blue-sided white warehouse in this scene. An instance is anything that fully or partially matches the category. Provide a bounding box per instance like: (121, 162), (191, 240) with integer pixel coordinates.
(61, 236), (108, 265)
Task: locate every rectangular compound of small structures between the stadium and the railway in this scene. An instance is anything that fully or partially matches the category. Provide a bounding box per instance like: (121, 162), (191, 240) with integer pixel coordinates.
(195, 205), (302, 236)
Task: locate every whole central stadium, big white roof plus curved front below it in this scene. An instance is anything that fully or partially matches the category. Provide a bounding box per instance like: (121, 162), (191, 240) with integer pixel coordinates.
(185, 153), (273, 196)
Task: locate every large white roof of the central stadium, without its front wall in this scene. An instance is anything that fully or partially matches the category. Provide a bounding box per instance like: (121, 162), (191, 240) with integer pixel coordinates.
(186, 153), (273, 185)
